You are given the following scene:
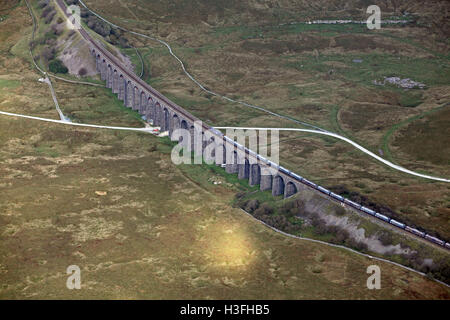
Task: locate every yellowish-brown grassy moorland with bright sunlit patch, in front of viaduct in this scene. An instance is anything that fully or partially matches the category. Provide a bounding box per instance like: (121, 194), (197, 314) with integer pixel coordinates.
(0, 4), (449, 299)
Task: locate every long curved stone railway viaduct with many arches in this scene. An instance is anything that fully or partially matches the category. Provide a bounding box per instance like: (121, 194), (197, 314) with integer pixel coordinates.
(57, 0), (309, 197)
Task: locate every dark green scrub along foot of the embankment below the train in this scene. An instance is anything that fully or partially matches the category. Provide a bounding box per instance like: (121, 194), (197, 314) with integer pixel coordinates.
(234, 191), (450, 283)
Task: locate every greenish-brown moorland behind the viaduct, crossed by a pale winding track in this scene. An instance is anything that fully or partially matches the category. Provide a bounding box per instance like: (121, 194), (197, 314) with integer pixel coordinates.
(76, 0), (450, 239)
